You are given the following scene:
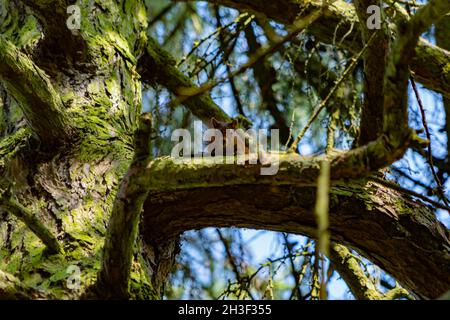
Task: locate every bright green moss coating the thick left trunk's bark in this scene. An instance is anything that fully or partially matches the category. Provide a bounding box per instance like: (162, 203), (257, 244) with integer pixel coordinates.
(0, 0), (156, 298)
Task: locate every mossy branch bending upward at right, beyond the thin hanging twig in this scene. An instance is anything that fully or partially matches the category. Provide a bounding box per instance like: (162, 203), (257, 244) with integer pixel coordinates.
(332, 1), (450, 178)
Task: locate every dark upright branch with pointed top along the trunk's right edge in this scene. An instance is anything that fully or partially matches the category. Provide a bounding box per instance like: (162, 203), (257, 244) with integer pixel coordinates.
(96, 113), (155, 299)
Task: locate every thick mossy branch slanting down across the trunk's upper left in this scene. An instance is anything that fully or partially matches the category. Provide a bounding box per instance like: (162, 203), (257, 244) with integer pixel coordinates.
(0, 37), (73, 148)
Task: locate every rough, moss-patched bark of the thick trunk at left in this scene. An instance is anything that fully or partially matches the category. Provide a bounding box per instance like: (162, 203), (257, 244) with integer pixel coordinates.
(0, 0), (154, 299)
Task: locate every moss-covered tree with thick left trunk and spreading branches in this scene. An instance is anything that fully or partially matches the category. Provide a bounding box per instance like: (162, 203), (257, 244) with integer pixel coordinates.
(0, 0), (450, 299)
